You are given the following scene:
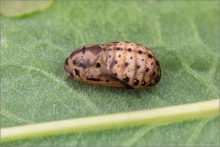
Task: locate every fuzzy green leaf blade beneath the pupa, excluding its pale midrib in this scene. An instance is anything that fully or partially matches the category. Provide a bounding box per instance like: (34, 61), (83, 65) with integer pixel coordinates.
(1, 1), (220, 146)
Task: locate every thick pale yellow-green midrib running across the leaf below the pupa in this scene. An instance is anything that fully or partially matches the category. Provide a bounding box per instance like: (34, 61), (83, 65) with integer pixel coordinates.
(1, 99), (219, 144)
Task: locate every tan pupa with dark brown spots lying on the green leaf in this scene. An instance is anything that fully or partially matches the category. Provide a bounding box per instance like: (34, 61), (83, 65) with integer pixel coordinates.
(64, 41), (161, 89)
